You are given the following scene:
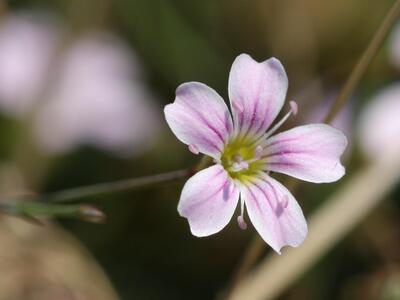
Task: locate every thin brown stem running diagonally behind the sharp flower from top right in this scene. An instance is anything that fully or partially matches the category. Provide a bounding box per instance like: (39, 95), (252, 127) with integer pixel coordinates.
(220, 0), (400, 299)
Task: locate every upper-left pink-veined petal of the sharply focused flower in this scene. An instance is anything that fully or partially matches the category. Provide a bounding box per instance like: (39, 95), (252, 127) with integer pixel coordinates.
(164, 82), (233, 158)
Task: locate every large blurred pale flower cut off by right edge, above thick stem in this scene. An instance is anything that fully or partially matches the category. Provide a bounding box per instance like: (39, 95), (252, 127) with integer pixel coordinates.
(359, 83), (400, 159)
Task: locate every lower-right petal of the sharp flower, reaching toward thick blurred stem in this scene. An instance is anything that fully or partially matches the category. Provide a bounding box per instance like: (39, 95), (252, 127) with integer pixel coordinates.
(241, 175), (307, 254)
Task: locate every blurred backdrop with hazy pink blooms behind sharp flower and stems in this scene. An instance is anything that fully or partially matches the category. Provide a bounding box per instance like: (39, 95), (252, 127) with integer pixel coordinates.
(0, 0), (400, 300)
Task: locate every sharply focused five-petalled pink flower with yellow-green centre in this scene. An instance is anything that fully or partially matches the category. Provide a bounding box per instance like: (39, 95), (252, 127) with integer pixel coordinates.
(164, 54), (347, 253)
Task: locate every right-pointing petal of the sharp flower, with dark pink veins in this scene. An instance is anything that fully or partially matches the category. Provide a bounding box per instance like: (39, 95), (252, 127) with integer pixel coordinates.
(263, 124), (347, 183)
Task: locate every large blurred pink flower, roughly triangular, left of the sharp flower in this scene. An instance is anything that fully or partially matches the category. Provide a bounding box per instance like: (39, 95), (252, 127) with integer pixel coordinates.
(35, 32), (159, 154)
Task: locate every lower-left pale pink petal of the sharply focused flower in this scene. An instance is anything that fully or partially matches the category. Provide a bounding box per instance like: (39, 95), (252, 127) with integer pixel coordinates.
(178, 165), (239, 237)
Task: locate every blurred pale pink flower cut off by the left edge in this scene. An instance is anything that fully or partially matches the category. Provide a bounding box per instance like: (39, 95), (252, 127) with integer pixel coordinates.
(0, 13), (59, 117)
